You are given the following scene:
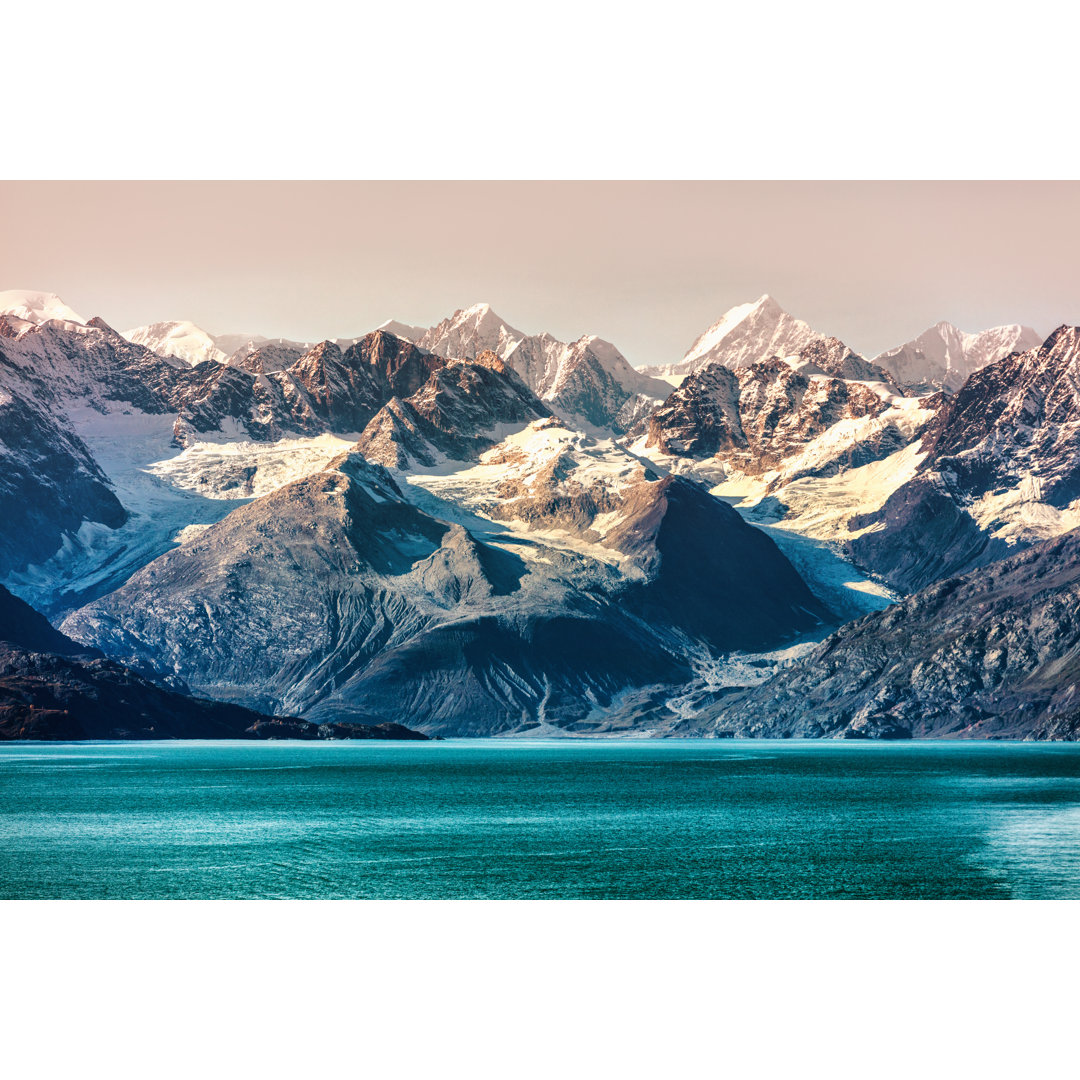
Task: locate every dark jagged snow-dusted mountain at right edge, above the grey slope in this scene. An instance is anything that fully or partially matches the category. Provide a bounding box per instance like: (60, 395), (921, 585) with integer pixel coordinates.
(848, 326), (1080, 590)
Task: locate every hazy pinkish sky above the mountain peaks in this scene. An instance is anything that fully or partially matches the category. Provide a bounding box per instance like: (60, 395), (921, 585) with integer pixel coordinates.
(0, 181), (1080, 365)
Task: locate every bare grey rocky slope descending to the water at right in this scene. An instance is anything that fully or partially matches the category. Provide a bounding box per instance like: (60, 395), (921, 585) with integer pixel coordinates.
(681, 531), (1080, 739)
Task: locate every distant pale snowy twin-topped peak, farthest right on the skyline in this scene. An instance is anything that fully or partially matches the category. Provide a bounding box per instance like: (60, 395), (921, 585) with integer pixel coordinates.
(874, 322), (1042, 393)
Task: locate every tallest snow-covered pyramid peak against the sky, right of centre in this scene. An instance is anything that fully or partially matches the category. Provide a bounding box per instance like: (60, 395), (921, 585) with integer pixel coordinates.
(645, 294), (823, 378)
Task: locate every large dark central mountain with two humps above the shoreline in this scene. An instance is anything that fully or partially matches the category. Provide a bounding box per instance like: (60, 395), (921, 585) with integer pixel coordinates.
(64, 454), (824, 734)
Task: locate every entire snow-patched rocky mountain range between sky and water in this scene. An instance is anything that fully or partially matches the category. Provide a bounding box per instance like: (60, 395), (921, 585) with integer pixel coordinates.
(0, 292), (1080, 738)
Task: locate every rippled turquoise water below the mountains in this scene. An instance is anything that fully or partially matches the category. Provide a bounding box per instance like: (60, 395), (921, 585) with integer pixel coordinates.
(0, 740), (1080, 899)
